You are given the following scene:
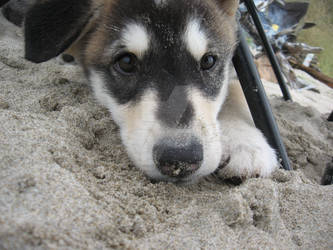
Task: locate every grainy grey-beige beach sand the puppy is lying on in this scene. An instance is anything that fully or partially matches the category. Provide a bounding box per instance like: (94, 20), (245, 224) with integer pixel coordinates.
(0, 14), (333, 249)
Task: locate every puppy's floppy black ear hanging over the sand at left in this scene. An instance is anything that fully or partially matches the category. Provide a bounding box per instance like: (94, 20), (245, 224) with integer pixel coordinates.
(24, 0), (96, 63)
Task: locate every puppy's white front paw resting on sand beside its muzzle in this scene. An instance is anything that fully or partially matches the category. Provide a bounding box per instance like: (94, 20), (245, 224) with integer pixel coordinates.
(216, 126), (278, 179)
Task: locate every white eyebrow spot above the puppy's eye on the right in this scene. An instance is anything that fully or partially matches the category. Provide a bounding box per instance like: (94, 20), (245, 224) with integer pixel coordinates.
(184, 19), (208, 61)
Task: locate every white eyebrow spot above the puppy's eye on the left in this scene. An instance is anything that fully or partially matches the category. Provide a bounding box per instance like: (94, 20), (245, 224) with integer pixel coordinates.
(122, 23), (150, 57)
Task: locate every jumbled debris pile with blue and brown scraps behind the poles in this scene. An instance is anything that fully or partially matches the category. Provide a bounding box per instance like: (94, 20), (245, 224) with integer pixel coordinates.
(240, 0), (333, 88)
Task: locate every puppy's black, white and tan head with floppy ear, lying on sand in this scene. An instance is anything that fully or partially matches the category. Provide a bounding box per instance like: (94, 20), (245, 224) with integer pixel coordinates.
(25, 0), (238, 181)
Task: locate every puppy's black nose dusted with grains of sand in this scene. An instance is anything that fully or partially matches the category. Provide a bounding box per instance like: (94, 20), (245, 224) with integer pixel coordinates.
(153, 139), (203, 178)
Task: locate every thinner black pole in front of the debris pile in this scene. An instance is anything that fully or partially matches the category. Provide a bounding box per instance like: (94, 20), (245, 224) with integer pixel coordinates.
(244, 0), (292, 101)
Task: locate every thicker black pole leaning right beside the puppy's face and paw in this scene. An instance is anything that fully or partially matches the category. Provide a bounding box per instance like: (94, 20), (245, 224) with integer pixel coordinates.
(233, 28), (292, 170)
